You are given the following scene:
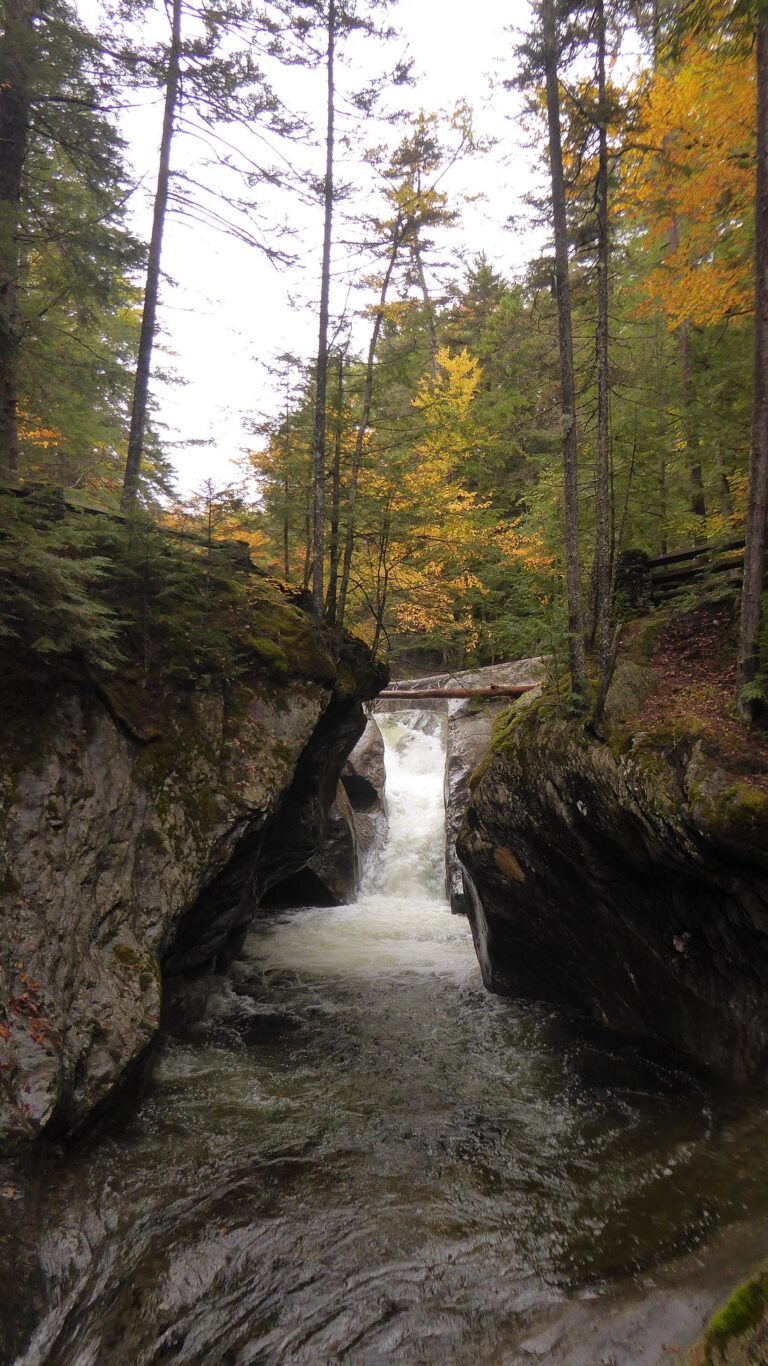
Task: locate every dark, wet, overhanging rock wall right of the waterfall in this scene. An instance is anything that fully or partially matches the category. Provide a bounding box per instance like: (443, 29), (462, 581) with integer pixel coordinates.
(458, 663), (768, 1081)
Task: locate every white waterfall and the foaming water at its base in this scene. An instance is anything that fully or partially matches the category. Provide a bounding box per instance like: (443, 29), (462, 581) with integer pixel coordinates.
(250, 712), (478, 981)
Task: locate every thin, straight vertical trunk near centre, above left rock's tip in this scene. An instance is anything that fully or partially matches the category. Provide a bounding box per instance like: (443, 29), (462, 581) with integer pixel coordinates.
(312, 0), (336, 617)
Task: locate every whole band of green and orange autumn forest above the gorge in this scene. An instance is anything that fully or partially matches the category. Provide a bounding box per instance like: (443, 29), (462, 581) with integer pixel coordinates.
(0, 0), (768, 714)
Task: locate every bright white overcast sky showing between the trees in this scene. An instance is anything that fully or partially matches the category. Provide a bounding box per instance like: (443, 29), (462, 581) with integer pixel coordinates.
(112, 0), (538, 490)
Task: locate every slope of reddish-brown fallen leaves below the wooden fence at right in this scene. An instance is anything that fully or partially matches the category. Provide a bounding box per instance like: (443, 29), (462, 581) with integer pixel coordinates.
(625, 601), (768, 791)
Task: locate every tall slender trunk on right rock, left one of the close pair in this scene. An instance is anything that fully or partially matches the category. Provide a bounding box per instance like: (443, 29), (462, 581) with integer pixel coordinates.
(543, 0), (586, 701)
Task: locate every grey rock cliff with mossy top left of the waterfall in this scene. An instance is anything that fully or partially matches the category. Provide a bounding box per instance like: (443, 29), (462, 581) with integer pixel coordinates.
(0, 605), (384, 1143)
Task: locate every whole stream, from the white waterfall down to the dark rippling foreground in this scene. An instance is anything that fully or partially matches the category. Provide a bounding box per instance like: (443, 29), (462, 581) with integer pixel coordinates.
(0, 712), (768, 1366)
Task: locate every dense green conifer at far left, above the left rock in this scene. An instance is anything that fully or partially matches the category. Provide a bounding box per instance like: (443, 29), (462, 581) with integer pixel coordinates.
(0, 0), (141, 482)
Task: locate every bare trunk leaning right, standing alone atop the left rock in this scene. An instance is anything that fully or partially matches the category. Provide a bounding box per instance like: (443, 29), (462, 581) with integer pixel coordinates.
(120, 0), (182, 508)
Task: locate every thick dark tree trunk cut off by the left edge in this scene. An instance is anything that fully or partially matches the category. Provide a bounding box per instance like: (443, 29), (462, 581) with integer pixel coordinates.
(0, 0), (34, 477)
